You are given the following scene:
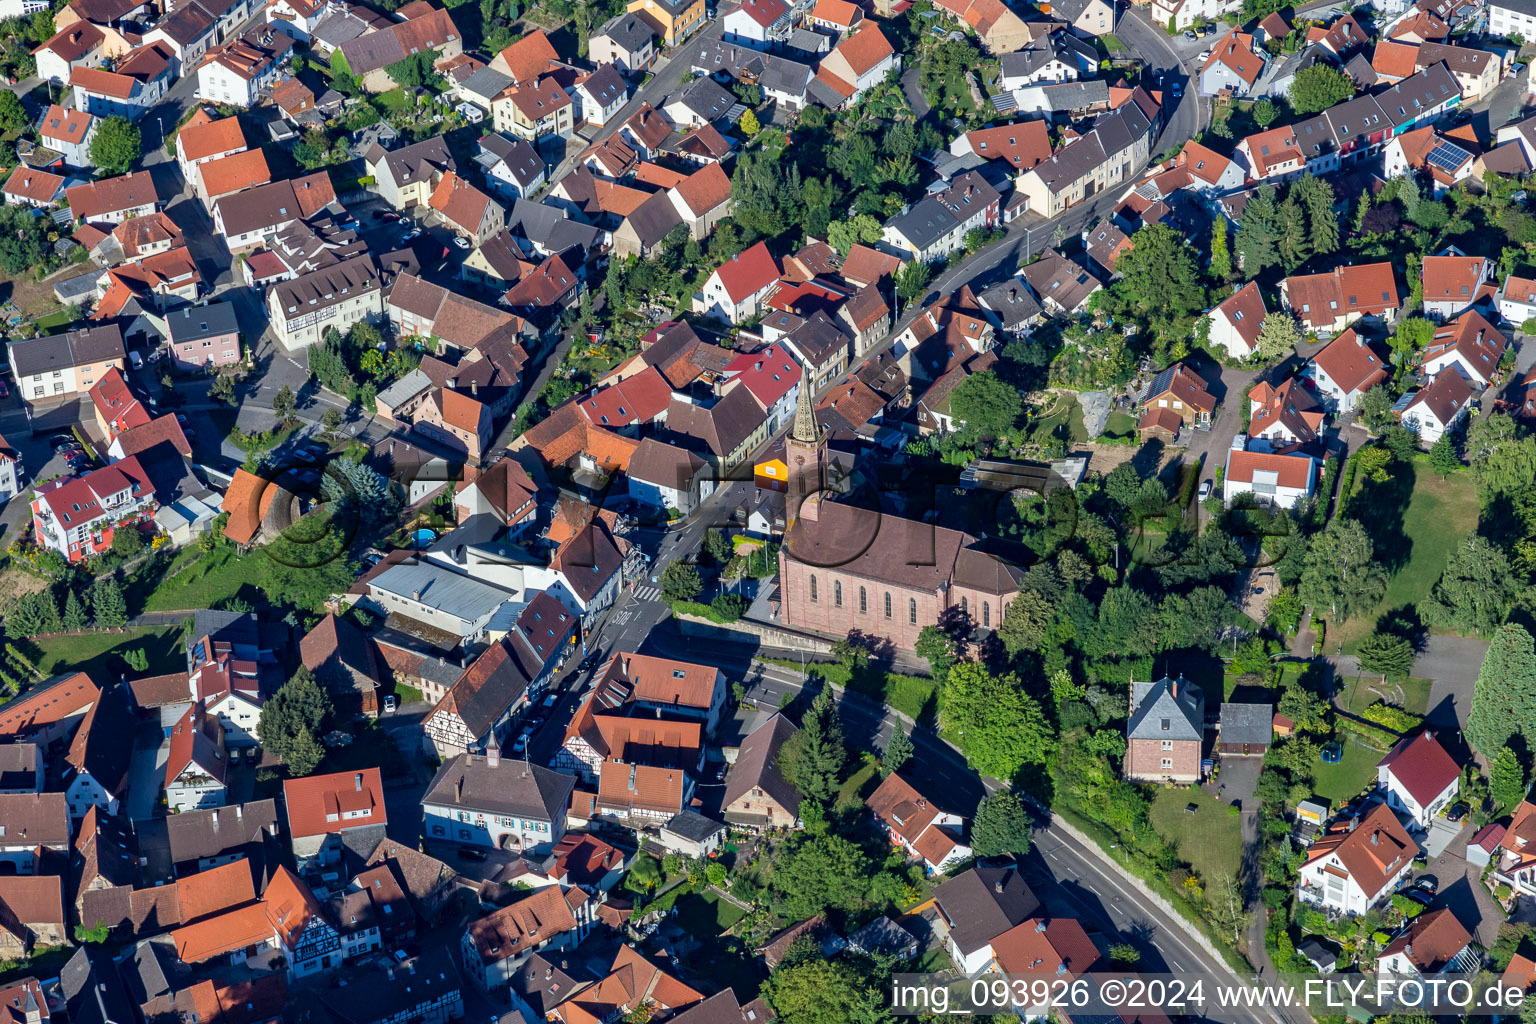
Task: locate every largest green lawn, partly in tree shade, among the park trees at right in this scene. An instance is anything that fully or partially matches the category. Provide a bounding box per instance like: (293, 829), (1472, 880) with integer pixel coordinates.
(1327, 464), (1478, 654)
